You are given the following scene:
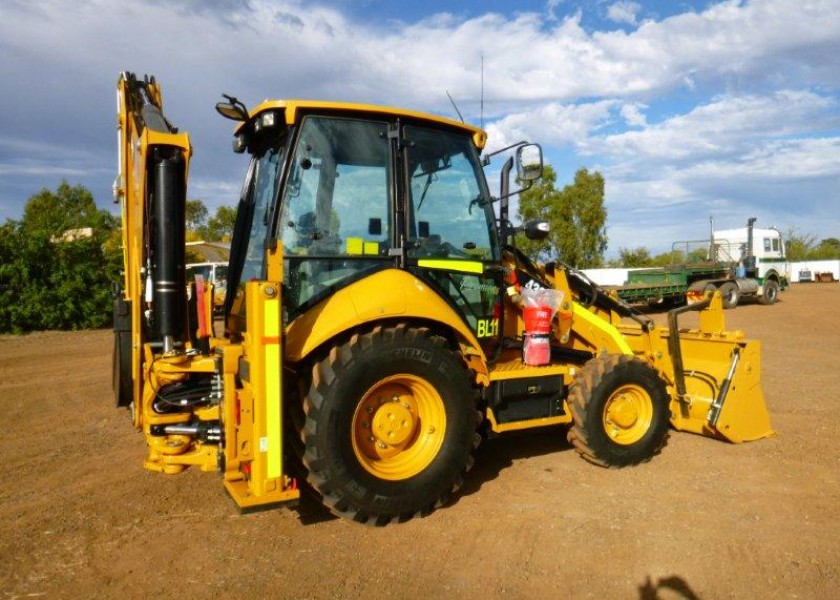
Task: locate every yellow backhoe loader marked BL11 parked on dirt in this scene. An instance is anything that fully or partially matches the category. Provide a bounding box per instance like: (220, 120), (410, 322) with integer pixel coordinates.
(113, 73), (772, 525)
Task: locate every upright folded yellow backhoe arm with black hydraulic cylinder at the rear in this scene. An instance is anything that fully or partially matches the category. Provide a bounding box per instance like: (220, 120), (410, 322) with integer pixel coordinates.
(114, 72), (192, 404)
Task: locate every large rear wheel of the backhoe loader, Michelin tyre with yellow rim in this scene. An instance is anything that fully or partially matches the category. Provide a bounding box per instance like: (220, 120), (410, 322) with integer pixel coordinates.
(302, 326), (479, 525)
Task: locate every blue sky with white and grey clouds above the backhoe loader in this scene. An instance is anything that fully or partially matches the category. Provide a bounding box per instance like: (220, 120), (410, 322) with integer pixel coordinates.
(0, 0), (840, 256)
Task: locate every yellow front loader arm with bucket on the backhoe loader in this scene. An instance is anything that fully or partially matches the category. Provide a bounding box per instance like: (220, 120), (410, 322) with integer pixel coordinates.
(508, 248), (773, 443)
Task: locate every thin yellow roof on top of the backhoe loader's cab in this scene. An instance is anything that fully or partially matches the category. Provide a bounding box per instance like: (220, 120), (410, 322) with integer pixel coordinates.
(237, 99), (487, 149)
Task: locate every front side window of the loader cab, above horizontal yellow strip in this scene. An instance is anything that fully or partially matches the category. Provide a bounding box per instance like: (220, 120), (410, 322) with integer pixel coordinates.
(405, 126), (498, 260)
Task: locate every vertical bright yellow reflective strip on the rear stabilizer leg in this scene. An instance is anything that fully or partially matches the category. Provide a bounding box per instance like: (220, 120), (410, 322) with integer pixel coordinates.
(263, 299), (283, 479)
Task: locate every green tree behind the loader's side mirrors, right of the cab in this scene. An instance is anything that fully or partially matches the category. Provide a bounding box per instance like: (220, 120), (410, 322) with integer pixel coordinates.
(517, 165), (607, 269)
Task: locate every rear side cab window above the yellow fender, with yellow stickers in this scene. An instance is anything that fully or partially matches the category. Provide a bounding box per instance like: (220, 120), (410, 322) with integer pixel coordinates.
(279, 116), (391, 312)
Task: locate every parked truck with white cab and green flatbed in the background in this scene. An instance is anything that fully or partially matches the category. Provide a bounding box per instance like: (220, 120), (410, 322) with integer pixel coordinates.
(611, 218), (789, 308)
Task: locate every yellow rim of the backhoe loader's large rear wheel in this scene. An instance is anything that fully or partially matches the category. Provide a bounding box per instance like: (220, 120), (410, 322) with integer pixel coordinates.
(352, 375), (446, 481)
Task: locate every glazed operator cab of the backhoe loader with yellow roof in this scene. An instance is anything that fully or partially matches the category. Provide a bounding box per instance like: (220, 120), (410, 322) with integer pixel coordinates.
(218, 102), (541, 339)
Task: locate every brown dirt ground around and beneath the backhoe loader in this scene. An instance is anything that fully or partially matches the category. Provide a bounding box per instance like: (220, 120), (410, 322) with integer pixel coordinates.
(0, 283), (840, 600)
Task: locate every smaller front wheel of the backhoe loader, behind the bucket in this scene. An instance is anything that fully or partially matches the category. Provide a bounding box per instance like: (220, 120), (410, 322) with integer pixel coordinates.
(568, 354), (670, 467)
